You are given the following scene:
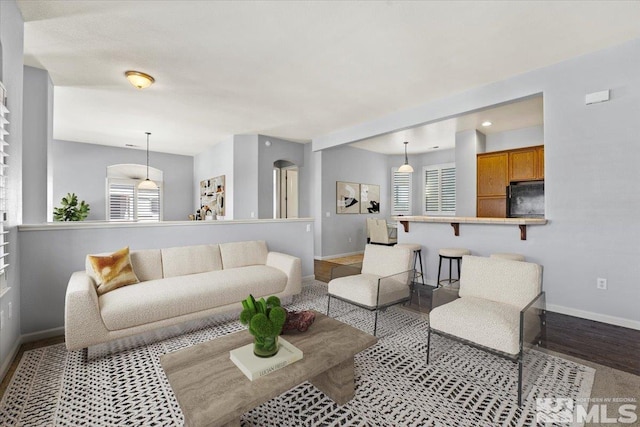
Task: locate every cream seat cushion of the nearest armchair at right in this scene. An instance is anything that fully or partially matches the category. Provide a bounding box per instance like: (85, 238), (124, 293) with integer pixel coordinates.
(430, 296), (520, 354)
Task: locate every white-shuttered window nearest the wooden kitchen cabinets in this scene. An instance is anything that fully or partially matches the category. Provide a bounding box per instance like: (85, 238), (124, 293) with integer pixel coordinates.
(422, 163), (456, 215)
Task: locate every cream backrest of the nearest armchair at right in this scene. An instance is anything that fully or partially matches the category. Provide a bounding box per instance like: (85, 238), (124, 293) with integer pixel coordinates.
(459, 255), (542, 310)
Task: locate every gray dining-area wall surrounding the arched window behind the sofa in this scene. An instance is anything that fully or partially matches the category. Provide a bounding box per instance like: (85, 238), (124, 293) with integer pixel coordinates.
(52, 140), (194, 223)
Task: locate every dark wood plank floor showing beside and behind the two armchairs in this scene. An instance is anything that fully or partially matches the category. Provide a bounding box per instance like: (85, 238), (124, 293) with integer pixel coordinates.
(315, 260), (640, 375)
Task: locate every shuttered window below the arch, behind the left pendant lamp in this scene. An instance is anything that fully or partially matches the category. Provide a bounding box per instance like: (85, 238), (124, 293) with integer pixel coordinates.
(107, 178), (162, 221)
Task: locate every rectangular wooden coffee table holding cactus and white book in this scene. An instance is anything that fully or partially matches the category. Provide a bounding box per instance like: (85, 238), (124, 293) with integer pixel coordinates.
(160, 312), (378, 427)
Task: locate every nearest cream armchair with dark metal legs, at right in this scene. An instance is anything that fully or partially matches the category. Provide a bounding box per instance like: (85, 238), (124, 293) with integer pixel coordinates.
(427, 255), (545, 406)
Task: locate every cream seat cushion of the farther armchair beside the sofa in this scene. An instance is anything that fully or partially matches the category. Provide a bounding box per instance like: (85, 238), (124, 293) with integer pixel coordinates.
(328, 274), (410, 308)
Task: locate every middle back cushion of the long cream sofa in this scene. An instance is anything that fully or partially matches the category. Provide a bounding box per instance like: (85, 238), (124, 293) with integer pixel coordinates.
(161, 245), (222, 278)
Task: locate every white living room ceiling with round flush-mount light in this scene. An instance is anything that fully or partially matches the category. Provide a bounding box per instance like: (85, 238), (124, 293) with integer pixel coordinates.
(18, 0), (640, 155)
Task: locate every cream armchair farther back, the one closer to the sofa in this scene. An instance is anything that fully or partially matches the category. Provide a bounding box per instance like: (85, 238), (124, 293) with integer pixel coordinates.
(327, 245), (413, 335)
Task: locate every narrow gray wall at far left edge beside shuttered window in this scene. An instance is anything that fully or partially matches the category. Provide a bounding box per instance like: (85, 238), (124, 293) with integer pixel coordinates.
(0, 1), (24, 378)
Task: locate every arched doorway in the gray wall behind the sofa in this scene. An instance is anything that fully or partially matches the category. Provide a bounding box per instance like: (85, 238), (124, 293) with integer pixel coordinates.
(273, 160), (298, 218)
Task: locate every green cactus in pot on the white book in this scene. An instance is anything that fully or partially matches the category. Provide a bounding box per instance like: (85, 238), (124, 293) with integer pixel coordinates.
(240, 295), (287, 357)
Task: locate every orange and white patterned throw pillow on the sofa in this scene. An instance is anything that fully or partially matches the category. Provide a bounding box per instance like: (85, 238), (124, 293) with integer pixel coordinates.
(89, 246), (140, 295)
